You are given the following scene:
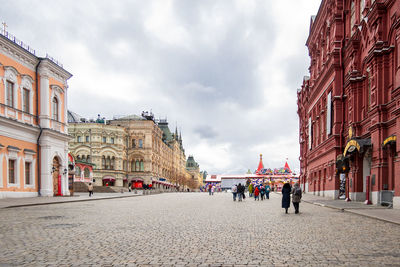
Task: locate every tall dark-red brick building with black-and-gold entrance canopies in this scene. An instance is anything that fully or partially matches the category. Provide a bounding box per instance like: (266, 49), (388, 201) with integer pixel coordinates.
(298, 0), (400, 207)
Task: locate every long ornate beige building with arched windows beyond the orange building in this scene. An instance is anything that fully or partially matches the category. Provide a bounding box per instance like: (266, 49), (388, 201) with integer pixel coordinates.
(69, 112), (194, 187)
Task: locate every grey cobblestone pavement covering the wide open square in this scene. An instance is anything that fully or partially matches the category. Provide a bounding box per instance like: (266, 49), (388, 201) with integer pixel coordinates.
(0, 193), (400, 266)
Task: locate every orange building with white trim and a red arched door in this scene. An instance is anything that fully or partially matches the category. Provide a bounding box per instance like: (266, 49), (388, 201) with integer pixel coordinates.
(0, 29), (72, 198)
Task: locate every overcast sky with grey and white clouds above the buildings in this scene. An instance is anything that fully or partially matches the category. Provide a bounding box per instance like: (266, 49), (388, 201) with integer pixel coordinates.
(0, 0), (321, 173)
